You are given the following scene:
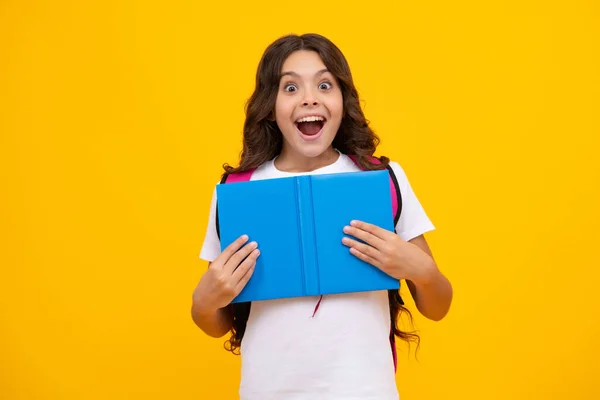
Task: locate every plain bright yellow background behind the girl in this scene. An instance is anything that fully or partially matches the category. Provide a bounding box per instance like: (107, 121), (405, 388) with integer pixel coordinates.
(0, 0), (600, 400)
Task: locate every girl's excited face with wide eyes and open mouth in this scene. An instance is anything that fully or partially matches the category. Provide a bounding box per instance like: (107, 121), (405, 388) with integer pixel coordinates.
(275, 50), (343, 169)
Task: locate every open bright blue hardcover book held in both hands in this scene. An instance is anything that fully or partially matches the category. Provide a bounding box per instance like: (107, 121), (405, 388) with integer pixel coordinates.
(217, 170), (400, 303)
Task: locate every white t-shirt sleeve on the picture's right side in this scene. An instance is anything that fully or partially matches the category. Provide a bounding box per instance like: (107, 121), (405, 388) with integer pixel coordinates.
(390, 161), (435, 241)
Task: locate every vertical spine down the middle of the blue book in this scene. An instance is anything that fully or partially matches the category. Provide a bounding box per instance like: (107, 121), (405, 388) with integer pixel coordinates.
(296, 176), (320, 296)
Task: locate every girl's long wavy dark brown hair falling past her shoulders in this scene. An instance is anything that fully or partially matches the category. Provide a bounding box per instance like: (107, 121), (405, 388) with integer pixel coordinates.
(223, 34), (420, 354)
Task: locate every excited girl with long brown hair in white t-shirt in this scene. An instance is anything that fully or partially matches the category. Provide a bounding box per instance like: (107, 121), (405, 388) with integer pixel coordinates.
(192, 34), (452, 400)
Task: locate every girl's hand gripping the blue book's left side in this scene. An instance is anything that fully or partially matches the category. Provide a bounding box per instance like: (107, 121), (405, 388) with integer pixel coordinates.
(193, 235), (260, 314)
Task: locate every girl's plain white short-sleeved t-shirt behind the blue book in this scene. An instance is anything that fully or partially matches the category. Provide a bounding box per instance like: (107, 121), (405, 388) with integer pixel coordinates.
(200, 154), (434, 400)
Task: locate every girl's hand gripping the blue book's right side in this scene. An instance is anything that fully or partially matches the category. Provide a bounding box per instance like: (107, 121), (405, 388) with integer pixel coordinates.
(342, 221), (435, 283)
